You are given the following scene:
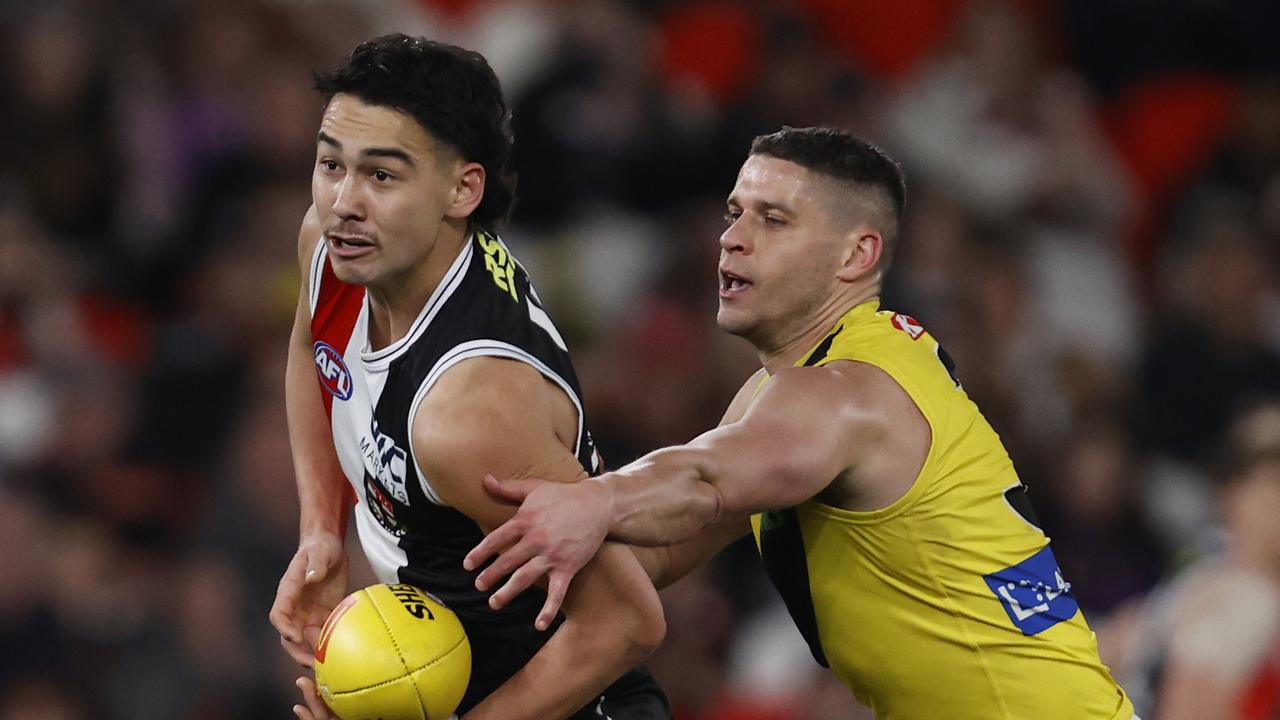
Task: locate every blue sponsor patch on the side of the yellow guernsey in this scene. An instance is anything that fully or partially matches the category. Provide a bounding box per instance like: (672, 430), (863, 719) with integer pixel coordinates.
(983, 546), (1080, 635)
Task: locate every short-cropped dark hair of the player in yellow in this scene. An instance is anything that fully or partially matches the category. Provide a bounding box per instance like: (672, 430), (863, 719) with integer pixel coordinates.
(751, 127), (906, 266)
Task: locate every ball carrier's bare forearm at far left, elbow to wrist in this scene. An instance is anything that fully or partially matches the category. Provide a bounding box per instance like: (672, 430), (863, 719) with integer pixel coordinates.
(284, 316), (349, 537)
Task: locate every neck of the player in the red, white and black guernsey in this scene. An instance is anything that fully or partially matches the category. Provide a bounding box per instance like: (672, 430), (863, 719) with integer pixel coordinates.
(366, 224), (471, 350)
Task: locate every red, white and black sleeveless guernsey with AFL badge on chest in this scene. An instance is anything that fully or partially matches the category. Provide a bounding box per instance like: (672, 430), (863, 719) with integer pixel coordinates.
(310, 232), (671, 720)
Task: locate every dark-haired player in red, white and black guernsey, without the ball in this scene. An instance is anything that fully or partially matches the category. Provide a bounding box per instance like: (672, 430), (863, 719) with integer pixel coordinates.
(270, 35), (671, 720)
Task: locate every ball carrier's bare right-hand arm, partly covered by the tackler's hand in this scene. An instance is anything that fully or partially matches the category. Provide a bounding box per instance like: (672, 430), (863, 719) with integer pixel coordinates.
(412, 357), (666, 720)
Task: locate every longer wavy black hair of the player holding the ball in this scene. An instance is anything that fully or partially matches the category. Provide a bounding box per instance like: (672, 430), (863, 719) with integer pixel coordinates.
(315, 33), (516, 231)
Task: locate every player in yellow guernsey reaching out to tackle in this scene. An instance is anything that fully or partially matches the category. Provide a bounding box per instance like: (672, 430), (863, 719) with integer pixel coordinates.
(466, 128), (1134, 720)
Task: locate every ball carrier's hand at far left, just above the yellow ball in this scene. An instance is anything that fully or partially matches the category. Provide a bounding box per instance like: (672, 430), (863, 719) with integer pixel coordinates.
(269, 533), (347, 667)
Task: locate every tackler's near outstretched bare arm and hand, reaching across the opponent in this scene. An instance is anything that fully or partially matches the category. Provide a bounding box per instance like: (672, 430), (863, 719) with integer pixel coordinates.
(466, 363), (886, 614)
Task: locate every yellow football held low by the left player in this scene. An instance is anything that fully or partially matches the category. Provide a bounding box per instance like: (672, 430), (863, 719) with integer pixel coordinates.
(315, 584), (471, 720)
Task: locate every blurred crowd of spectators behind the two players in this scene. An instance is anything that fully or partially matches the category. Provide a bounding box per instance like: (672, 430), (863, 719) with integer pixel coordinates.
(0, 0), (1280, 720)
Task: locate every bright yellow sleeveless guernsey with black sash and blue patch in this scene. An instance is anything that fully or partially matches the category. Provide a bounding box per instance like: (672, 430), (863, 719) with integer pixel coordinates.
(751, 300), (1133, 720)
